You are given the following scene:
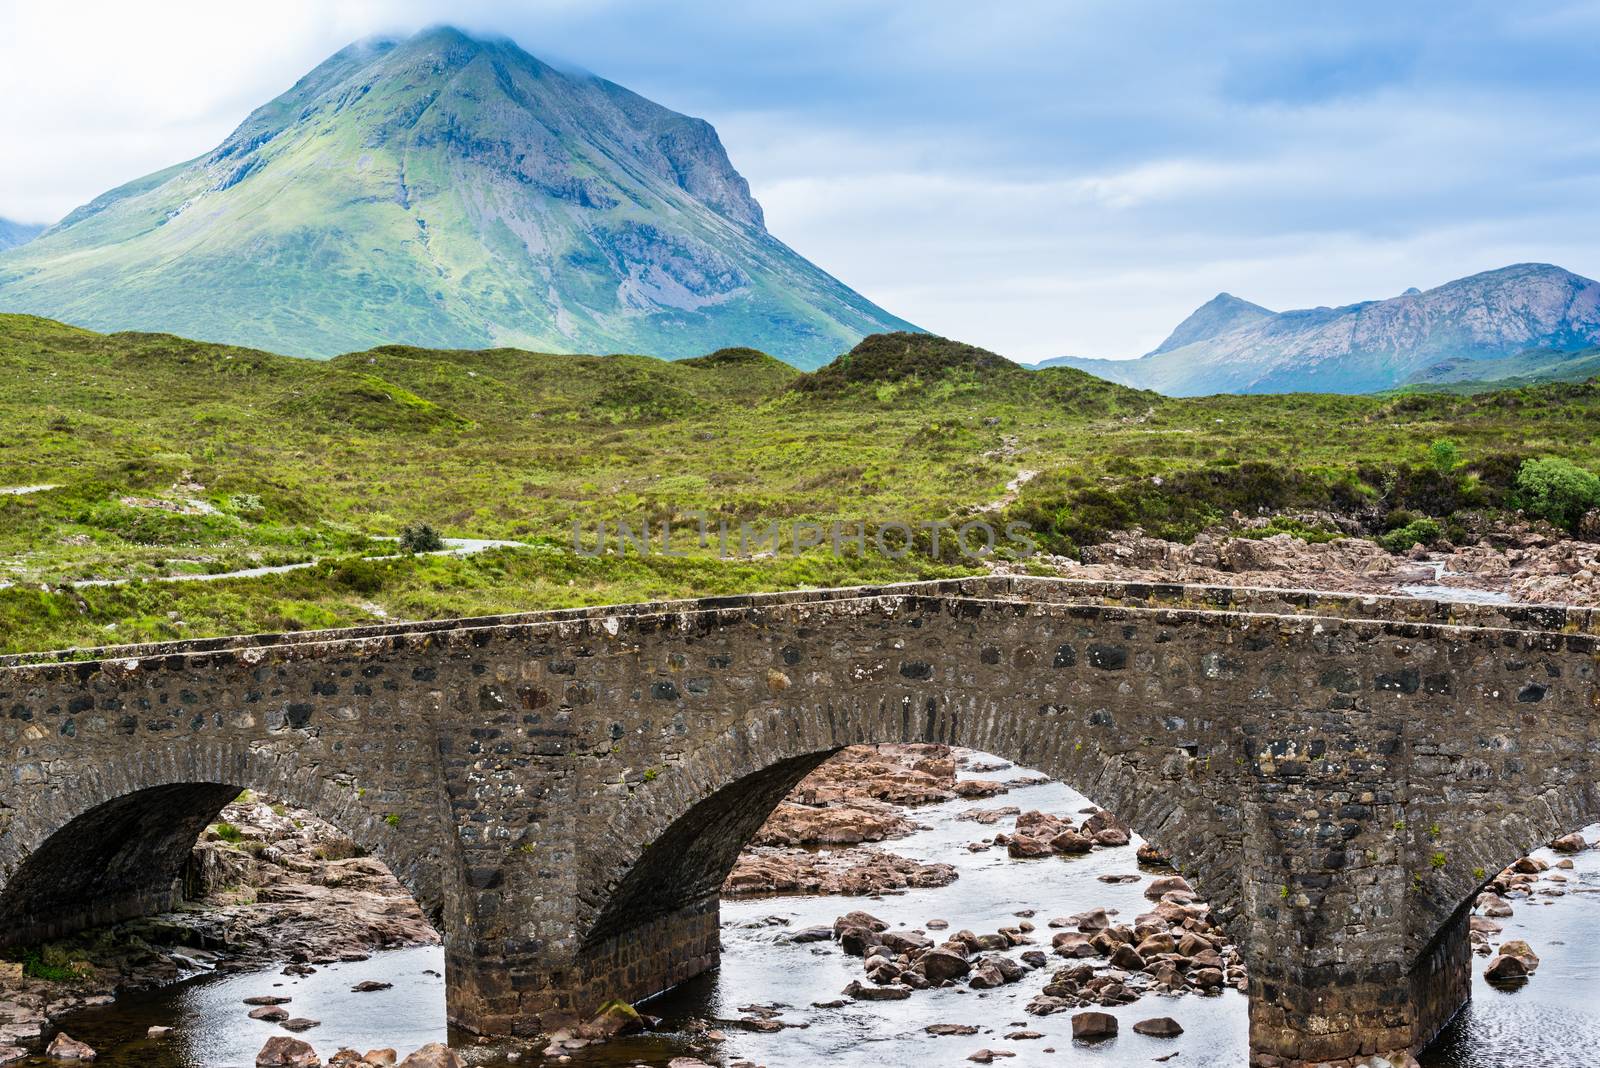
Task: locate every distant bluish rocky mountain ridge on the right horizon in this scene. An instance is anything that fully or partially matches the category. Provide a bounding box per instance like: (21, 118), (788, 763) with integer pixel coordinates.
(1050, 264), (1600, 397)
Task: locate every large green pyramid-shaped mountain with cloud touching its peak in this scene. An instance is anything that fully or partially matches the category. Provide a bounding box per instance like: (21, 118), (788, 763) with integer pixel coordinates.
(0, 29), (915, 366)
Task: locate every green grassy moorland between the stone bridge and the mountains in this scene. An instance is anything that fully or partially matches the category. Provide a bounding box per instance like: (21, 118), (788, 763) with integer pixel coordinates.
(0, 315), (1600, 651)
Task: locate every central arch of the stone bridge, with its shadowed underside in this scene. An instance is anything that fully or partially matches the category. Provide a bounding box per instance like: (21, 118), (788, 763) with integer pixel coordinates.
(579, 699), (1243, 951)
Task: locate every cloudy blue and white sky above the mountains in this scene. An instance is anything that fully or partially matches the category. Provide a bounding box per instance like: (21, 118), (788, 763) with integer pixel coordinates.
(0, 0), (1600, 360)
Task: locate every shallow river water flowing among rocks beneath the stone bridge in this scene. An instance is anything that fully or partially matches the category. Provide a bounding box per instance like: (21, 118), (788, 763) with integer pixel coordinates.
(32, 757), (1600, 1068)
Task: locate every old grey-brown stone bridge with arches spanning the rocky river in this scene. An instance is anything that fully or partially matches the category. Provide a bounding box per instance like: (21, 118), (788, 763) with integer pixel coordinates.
(0, 579), (1600, 1065)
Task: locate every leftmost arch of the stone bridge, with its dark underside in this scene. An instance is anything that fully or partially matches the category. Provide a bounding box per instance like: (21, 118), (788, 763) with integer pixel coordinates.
(0, 742), (445, 945)
